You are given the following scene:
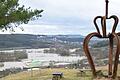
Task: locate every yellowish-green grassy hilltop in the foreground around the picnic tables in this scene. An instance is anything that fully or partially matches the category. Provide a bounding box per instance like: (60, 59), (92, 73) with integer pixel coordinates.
(0, 66), (120, 80)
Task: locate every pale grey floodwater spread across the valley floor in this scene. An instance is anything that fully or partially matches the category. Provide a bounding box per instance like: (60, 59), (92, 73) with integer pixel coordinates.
(0, 49), (86, 70)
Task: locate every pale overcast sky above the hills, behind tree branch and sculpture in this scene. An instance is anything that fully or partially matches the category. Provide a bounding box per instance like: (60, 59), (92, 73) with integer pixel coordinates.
(1, 0), (120, 35)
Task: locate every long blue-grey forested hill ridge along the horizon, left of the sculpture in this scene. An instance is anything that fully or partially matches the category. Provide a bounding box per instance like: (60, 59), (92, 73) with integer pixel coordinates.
(0, 34), (84, 48)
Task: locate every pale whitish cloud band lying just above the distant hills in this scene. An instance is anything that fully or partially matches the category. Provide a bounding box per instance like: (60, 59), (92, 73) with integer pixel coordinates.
(0, 24), (93, 35)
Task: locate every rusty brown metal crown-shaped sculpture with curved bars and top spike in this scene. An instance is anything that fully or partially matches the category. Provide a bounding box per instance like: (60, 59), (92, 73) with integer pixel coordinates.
(83, 0), (120, 78)
